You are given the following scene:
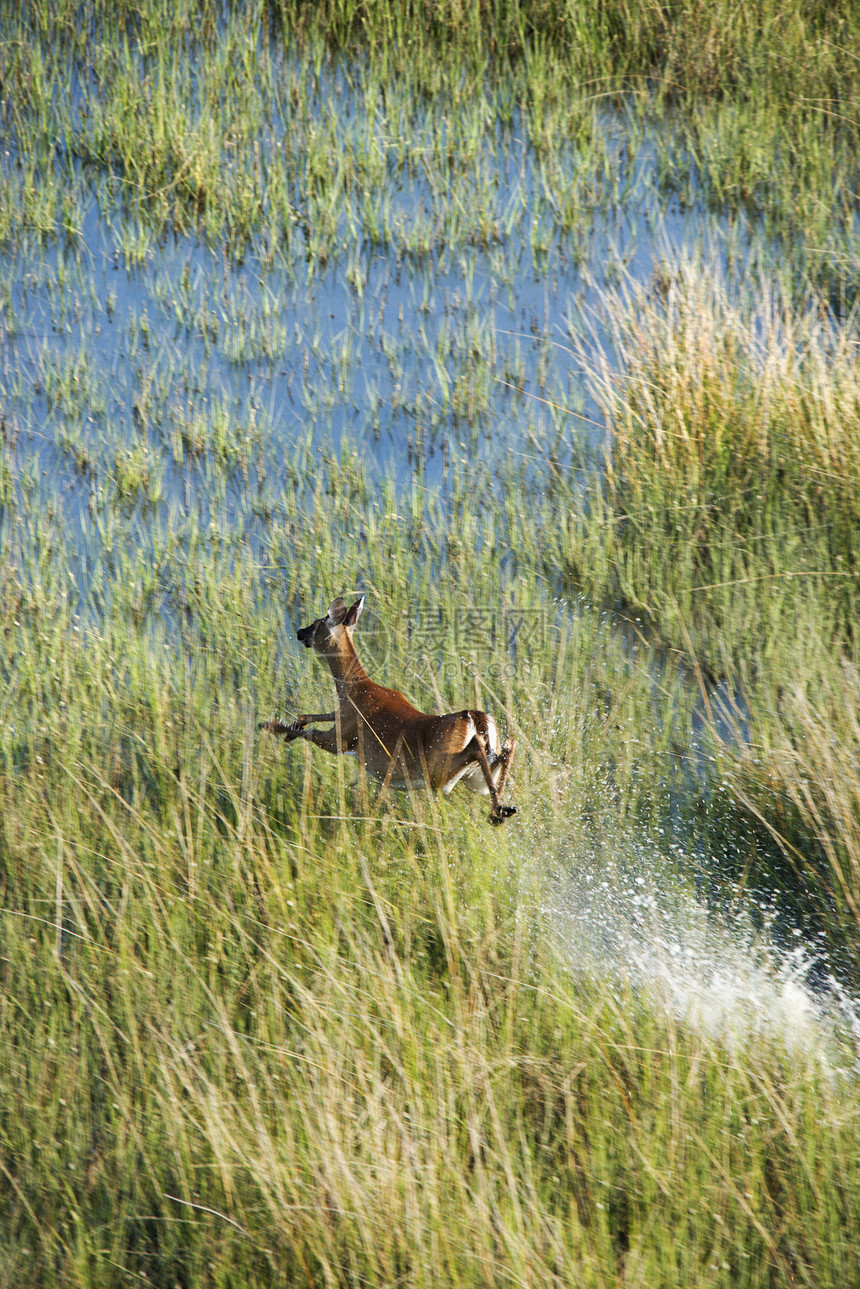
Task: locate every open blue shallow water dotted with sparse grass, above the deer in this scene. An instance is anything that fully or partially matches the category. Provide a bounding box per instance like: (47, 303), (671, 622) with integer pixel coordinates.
(0, 117), (752, 531)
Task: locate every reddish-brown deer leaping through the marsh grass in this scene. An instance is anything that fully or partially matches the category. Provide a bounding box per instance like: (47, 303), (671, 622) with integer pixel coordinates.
(260, 596), (517, 824)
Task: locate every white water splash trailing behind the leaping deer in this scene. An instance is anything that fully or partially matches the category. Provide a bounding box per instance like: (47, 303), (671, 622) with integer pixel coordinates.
(547, 842), (860, 1075)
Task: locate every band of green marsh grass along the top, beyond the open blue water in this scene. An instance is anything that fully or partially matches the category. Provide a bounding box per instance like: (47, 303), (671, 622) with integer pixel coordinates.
(0, 0), (857, 291)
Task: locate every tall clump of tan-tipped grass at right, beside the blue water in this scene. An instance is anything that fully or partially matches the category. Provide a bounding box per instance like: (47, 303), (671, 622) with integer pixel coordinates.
(552, 260), (860, 948)
